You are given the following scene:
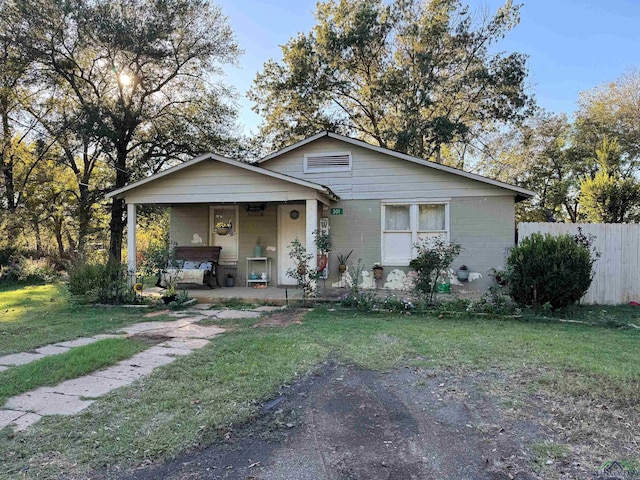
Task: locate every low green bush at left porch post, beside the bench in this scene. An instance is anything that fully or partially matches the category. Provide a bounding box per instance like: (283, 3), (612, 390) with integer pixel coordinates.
(68, 261), (138, 304)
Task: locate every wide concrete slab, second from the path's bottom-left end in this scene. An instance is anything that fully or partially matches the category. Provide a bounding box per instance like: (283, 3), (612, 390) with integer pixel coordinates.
(5, 387), (94, 415)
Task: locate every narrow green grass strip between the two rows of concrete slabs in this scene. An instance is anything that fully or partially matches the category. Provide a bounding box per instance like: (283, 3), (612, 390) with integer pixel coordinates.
(0, 338), (149, 405)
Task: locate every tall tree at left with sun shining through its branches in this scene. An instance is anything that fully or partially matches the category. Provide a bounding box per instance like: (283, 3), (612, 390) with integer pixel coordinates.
(16, 0), (238, 260)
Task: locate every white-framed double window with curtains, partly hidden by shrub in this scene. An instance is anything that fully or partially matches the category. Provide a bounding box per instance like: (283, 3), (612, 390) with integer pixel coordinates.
(382, 203), (449, 266)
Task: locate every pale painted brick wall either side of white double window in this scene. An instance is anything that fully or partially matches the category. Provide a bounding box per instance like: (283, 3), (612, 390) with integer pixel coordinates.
(328, 195), (514, 290)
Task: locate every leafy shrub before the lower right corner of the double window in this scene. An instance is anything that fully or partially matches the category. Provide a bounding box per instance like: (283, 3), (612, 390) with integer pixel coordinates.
(409, 237), (462, 303)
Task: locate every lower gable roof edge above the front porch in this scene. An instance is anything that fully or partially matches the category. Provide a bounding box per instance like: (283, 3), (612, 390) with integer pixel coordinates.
(105, 153), (340, 200)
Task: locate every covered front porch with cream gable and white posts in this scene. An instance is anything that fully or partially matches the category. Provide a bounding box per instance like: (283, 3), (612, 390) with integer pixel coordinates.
(108, 154), (339, 288)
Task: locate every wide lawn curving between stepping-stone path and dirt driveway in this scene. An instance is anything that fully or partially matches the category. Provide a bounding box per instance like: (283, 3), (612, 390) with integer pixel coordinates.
(0, 308), (640, 478)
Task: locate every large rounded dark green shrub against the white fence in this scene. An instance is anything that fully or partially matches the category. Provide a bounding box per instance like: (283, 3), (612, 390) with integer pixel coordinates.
(507, 233), (595, 309)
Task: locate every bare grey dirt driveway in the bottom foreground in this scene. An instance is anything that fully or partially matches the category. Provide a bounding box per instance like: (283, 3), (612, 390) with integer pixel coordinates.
(117, 365), (542, 480)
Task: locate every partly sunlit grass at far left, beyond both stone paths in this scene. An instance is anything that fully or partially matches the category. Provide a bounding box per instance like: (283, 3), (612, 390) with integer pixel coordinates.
(0, 284), (166, 355)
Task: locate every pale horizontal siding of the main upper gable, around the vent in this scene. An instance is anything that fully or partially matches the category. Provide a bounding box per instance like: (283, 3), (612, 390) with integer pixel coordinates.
(262, 138), (514, 200)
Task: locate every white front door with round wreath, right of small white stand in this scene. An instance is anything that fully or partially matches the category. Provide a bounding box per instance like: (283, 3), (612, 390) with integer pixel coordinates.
(278, 204), (307, 285)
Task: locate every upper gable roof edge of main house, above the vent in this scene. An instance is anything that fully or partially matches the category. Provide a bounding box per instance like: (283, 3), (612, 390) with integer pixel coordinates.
(256, 131), (536, 201)
